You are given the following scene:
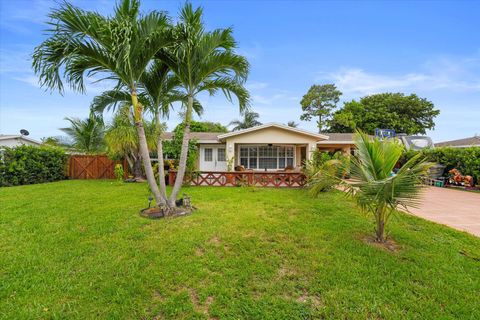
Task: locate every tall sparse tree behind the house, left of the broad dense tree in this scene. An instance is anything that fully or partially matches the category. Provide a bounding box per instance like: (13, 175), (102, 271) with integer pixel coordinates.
(300, 84), (342, 132)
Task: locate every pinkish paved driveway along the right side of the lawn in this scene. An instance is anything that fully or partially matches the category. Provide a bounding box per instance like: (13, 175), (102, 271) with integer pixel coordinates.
(409, 187), (480, 237)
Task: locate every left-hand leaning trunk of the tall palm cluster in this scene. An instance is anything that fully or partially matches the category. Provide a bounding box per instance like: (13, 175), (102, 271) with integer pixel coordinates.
(131, 90), (165, 205)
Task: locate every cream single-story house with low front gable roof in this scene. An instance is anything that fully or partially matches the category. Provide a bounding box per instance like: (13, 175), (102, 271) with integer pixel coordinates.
(164, 123), (354, 171)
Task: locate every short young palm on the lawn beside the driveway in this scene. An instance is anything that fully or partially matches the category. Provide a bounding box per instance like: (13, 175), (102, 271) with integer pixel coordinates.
(347, 132), (431, 242)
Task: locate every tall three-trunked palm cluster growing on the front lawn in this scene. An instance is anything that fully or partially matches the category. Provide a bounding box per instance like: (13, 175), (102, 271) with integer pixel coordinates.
(33, 0), (249, 212)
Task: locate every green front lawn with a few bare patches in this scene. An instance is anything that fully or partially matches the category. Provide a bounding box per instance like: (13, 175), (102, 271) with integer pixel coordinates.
(0, 181), (480, 319)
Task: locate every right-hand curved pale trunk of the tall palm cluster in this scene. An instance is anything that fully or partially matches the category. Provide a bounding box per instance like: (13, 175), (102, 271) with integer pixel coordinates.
(168, 96), (193, 208)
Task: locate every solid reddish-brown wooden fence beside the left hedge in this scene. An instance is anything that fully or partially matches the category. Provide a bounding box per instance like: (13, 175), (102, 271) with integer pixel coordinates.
(68, 155), (128, 179)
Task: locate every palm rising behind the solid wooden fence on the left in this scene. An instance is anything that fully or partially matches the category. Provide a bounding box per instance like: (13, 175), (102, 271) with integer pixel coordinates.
(60, 115), (105, 153)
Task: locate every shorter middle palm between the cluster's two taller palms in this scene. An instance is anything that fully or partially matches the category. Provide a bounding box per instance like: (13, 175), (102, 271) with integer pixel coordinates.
(91, 60), (203, 202)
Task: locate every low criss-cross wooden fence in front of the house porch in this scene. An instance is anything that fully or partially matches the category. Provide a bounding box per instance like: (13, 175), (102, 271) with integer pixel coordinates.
(168, 171), (306, 188)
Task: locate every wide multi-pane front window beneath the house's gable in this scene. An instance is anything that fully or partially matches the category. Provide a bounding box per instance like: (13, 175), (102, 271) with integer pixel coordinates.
(240, 146), (294, 170)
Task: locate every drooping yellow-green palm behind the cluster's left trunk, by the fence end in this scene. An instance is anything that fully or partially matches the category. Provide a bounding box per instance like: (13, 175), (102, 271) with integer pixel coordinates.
(105, 103), (157, 178)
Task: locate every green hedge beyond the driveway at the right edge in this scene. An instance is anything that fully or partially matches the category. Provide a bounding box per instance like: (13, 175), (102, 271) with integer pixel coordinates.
(405, 147), (480, 184)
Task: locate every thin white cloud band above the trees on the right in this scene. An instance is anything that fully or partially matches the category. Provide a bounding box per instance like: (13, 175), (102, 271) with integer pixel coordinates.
(316, 56), (480, 95)
